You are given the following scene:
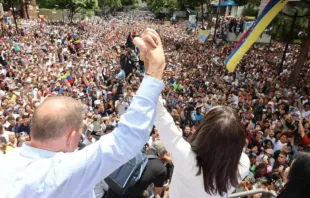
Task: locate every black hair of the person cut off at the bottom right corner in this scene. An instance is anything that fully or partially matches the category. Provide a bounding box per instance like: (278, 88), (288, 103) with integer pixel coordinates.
(278, 153), (310, 198)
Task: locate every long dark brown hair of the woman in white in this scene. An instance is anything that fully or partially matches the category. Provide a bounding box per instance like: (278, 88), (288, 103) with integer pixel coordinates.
(189, 106), (246, 196)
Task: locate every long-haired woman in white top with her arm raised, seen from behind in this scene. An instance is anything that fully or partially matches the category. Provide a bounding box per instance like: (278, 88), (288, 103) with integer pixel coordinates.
(155, 102), (250, 198)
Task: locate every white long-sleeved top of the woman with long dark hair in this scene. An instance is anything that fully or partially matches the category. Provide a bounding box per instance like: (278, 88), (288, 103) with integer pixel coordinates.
(155, 102), (250, 198)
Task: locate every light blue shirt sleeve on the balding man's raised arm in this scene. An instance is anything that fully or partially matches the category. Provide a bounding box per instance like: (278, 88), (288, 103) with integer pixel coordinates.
(47, 76), (164, 197)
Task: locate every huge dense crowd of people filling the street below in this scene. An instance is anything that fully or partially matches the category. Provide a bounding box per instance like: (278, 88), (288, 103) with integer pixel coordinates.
(0, 10), (310, 198)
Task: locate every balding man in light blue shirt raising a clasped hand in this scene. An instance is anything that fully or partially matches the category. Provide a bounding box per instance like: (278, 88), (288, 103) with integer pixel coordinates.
(0, 29), (165, 198)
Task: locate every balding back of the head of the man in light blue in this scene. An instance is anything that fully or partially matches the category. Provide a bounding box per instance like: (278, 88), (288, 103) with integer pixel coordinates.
(30, 96), (85, 141)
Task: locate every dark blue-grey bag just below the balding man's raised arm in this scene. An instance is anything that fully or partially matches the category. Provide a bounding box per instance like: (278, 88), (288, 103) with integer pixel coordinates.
(104, 152), (158, 195)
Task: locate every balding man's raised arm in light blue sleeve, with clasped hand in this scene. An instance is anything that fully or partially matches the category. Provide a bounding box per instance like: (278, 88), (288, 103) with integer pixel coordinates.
(55, 30), (165, 197)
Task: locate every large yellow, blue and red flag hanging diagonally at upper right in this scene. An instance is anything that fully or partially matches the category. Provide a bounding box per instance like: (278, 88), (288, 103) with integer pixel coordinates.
(225, 0), (288, 72)
